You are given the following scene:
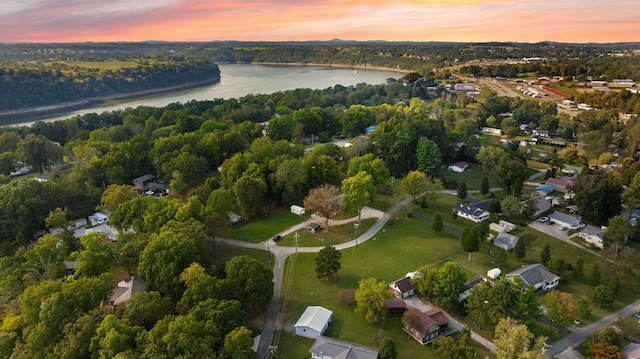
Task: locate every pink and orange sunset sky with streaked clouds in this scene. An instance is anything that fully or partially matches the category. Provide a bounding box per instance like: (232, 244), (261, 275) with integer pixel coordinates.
(0, 0), (640, 42)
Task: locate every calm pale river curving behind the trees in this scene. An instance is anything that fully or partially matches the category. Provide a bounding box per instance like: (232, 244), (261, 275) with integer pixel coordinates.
(7, 64), (404, 126)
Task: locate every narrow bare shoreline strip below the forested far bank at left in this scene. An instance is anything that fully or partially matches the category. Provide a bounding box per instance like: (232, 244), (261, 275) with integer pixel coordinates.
(0, 76), (220, 118)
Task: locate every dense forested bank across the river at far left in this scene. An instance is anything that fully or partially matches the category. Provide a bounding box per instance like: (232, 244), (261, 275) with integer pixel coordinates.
(0, 56), (220, 112)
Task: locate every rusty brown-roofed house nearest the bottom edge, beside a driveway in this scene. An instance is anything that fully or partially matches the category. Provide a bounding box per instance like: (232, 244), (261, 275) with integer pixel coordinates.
(402, 308), (449, 345)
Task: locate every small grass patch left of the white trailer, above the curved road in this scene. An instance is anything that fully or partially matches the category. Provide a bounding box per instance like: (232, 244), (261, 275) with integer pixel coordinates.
(229, 208), (310, 243)
